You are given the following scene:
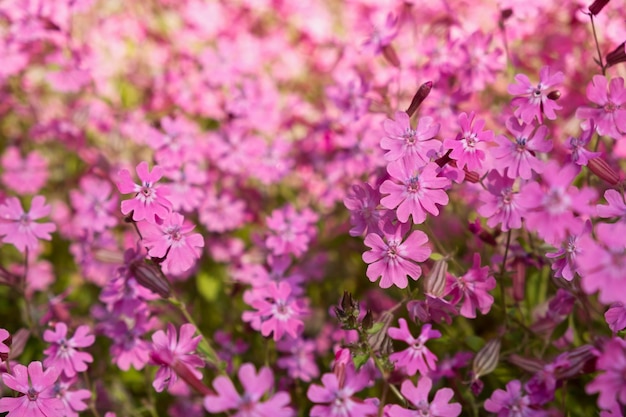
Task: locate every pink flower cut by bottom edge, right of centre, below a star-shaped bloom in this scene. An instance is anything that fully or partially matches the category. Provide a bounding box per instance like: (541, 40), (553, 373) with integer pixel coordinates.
(388, 376), (461, 417)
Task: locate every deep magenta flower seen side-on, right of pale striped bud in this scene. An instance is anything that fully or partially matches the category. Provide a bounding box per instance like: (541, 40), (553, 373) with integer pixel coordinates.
(447, 253), (496, 319)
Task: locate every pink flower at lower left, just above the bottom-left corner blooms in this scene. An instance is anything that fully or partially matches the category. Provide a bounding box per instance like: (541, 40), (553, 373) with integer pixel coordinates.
(43, 322), (96, 378)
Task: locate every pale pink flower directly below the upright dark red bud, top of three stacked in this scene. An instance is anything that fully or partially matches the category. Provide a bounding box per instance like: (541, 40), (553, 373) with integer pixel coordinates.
(380, 111), (441, 166)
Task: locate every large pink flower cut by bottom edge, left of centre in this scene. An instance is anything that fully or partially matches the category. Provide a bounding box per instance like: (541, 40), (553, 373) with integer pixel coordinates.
(204, 363), (295, 417)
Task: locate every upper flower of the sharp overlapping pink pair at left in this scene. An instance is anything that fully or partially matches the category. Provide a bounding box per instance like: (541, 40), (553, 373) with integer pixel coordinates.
(117, 162), (172, 223)
